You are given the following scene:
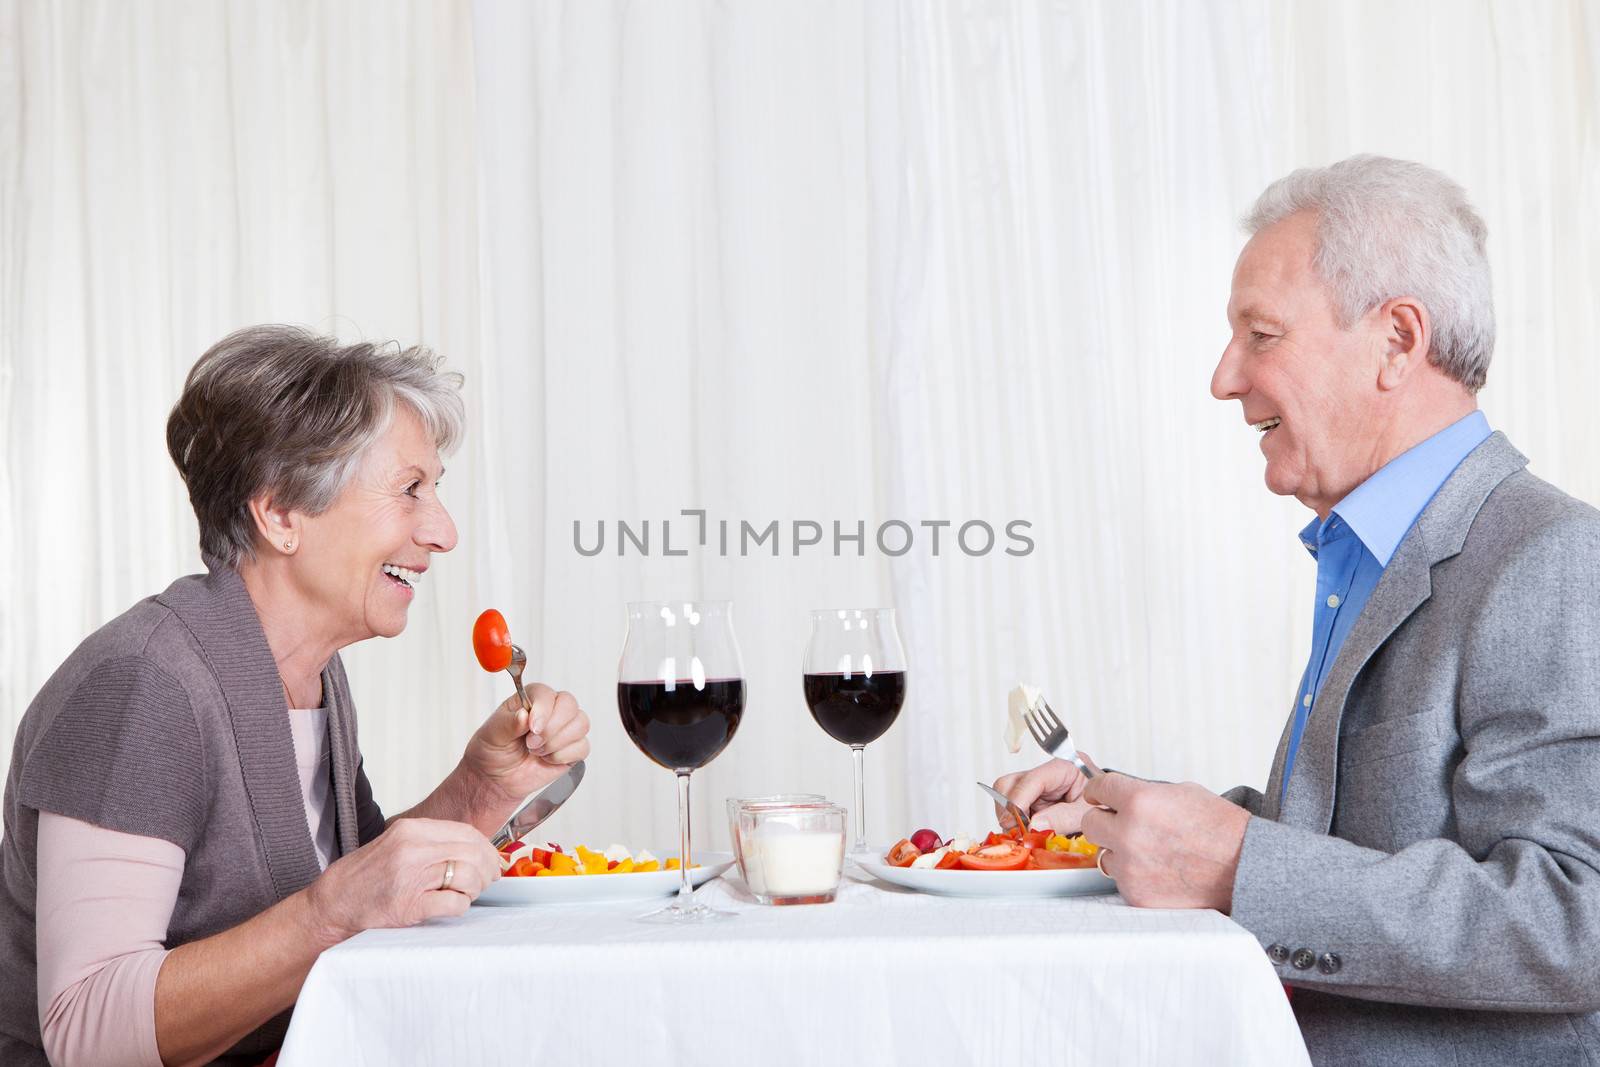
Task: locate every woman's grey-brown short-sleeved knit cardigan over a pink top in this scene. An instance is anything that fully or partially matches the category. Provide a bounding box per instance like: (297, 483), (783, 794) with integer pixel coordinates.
(0, 560), (384, 1067)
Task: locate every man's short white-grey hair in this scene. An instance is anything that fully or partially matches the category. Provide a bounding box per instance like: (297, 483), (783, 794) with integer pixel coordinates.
(1245, 155), (1494, 392)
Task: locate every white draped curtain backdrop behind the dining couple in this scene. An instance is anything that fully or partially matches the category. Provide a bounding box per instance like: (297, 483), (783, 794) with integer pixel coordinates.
(0, 0), (1600, 845)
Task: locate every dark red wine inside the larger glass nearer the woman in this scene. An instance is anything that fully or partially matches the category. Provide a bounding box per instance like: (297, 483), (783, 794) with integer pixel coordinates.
(616, 678), (744, 771)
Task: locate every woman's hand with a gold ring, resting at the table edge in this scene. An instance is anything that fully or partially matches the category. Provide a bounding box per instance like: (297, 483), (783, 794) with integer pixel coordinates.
(306, 819), (501, 941)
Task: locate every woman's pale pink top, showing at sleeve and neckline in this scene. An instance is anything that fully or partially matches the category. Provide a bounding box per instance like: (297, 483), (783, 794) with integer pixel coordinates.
(35, 707), (334, 1067)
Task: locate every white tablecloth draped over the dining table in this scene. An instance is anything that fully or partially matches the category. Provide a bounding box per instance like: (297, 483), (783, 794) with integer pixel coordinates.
(278, 875), (1309, 1067)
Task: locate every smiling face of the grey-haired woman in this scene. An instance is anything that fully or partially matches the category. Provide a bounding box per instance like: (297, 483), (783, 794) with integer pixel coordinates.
(291, 403), (456, 645)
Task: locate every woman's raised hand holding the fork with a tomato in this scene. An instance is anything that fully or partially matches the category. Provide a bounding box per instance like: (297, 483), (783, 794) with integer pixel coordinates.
(461, 681), (589, 803)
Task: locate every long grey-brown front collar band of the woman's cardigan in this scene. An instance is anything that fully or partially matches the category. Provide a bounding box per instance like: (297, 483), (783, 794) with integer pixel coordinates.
(158, 558), (331, 901)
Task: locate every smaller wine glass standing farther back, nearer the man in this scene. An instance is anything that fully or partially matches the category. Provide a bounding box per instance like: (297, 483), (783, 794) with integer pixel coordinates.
(803, 608), (906, 854)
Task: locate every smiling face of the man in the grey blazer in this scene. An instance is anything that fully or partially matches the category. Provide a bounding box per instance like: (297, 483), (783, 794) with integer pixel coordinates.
(1211, 213), (1381, 517)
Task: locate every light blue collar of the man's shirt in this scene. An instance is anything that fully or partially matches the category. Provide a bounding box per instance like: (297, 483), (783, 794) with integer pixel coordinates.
(1301, 411), (1490, 566)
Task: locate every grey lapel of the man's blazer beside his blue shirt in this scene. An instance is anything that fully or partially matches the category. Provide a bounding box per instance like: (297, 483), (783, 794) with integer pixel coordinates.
(1264, 434), (1528, 833)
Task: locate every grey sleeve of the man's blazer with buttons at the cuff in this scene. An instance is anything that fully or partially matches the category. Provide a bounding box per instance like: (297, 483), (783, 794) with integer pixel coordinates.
(1232, 509), (1600, 1013)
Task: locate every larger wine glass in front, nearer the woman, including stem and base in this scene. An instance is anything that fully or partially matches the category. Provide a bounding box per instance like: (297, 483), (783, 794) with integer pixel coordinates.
(616, 600), (744, 923)
